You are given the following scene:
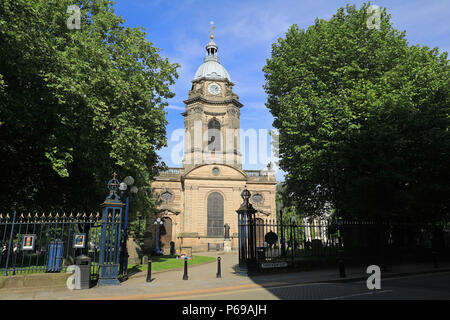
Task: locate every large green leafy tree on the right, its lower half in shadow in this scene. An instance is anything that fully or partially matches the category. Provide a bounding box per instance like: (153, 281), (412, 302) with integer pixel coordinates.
(263, 3), (450, 220)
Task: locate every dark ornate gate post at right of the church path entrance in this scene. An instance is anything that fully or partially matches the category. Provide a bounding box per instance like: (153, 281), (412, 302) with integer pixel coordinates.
(236, 189), (257, 272)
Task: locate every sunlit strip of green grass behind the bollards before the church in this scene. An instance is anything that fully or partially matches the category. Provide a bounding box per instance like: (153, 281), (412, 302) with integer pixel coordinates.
(128, 256), (216, 274)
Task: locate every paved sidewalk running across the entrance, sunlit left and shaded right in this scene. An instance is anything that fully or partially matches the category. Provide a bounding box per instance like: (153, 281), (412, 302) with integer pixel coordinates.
(0, 252), (450, 300)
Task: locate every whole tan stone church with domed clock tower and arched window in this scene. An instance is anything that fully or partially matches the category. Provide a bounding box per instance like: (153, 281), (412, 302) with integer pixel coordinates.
(145, 35), (276, 254)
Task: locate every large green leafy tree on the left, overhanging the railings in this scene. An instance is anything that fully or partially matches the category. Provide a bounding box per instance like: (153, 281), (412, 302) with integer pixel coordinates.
(0, 0), (178, 212)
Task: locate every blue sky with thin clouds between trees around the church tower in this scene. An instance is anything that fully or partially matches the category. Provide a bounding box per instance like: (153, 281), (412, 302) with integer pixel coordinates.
(110, 0), (450, 181)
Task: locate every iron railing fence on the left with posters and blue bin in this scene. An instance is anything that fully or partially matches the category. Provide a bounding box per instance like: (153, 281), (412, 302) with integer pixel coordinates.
(0, 212), (121, 281)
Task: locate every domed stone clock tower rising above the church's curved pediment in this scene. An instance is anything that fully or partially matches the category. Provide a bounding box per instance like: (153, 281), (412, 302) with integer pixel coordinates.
(182, 35), (243, 170)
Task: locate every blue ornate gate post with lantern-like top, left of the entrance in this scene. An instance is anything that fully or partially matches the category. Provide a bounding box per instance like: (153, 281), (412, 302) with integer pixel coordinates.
(98, 173), (124, 286)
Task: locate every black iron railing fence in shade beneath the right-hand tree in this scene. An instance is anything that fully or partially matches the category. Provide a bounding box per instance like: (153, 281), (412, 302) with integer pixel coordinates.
(239, 218), (450, 270)
